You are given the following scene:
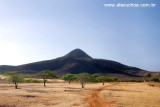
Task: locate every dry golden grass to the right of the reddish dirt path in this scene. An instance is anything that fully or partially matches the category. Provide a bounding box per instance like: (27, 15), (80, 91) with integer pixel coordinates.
(101, 83), (160, 107)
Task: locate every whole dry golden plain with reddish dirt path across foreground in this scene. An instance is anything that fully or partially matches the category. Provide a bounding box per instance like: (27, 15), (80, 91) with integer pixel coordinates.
(0, 81), (160, 107)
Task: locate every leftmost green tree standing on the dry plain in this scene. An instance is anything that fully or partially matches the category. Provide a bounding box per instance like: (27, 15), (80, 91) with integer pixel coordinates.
(6, 71), (24, 89)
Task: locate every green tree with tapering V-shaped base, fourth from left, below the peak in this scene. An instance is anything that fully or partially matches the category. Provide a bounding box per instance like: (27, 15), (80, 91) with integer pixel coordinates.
(76, 73), (90, 88)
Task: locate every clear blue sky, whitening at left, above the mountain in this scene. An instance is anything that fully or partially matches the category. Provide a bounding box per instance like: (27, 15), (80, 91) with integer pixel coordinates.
(0, 0), (160, 71)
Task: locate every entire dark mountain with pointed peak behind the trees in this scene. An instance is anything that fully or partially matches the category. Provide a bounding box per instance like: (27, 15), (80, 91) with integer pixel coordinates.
(0, 49), (160, 78)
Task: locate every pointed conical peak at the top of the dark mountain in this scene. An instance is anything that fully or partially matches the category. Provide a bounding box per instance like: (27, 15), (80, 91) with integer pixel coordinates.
(66, 48), (92, 58)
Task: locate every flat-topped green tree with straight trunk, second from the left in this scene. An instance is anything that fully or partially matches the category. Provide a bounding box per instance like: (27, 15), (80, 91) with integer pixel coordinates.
(39, 70), (56, 87)
